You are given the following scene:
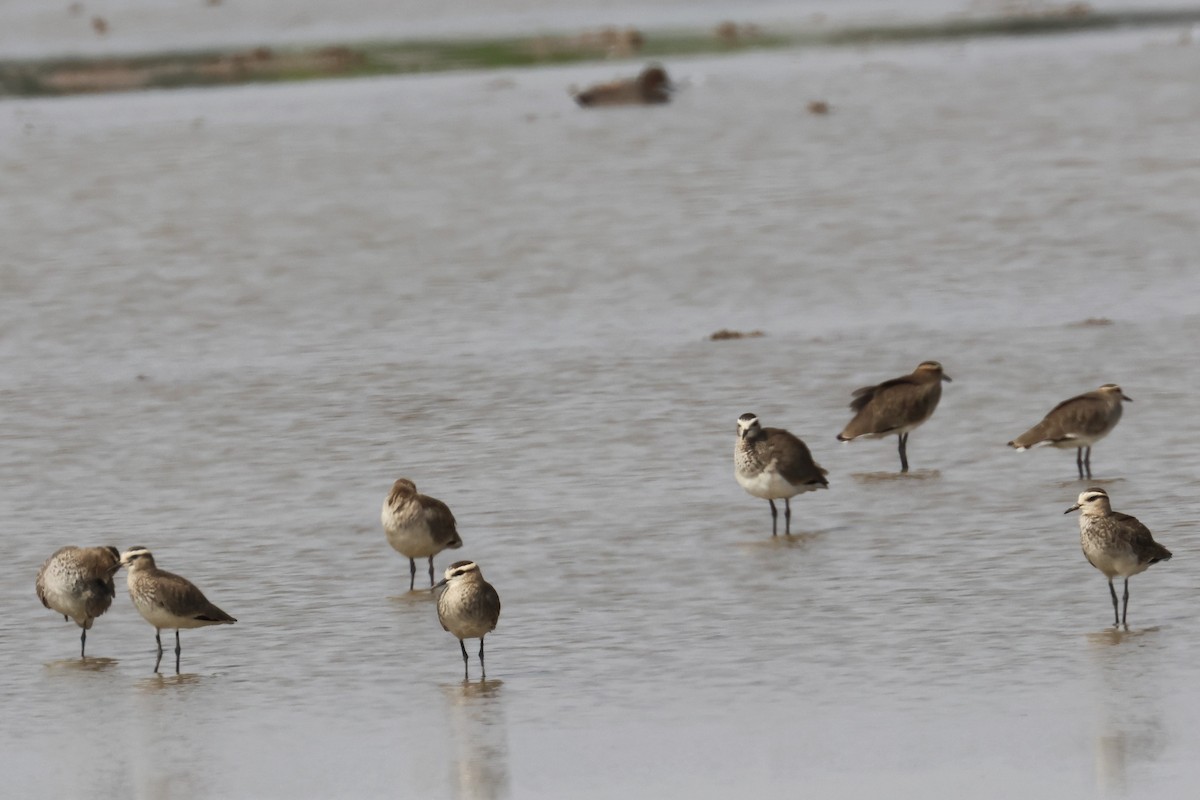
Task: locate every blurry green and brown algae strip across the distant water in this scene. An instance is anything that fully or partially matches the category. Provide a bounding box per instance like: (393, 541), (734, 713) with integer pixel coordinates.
(0, 4), (1200, 97)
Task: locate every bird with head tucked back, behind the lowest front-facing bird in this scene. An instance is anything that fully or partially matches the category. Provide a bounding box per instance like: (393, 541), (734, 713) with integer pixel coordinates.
(379, 477), (462, 591)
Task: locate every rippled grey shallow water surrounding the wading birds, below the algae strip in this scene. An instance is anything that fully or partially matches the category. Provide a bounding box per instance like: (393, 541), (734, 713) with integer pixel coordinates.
(0, 25), (1200, 798)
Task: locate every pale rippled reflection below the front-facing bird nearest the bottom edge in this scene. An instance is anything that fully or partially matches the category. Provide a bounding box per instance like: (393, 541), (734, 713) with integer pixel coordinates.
(443, 680), (510, 800)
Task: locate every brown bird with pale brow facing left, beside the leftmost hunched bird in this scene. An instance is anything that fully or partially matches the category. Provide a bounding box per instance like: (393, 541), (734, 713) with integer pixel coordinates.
(121, 547), (238, 675)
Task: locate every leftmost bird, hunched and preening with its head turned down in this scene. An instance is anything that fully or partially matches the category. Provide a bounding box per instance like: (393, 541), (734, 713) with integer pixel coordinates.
(35, 546), (121, 658)
